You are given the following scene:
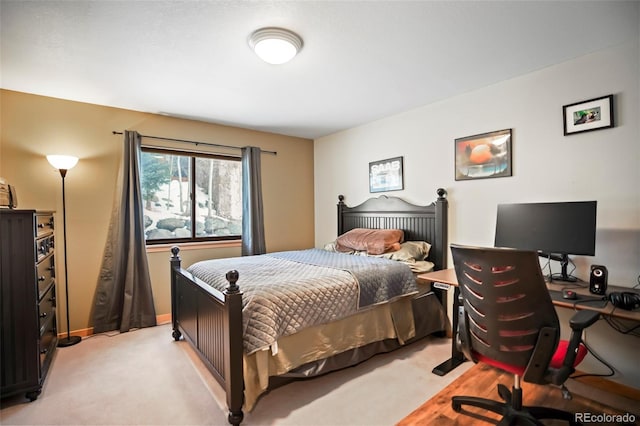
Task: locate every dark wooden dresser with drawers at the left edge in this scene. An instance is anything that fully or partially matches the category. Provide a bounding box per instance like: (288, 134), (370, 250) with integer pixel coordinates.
(0, 209), (58, 401)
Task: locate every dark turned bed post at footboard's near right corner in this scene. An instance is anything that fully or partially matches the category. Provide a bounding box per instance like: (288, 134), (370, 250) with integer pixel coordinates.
(223, 270), (244, 425)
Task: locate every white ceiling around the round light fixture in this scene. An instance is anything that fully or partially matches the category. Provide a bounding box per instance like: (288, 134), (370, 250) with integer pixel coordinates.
(0, 0), (640, 139)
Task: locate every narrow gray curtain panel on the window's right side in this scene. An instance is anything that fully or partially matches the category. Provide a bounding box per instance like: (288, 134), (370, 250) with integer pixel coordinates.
(242, 146), (267, 256)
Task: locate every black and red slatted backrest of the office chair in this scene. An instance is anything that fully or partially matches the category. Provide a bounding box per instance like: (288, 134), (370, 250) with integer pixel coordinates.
(451, 245), (560, 374)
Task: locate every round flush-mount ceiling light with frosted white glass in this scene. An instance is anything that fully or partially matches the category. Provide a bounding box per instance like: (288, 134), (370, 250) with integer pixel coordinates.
(249, 27), (302, 65)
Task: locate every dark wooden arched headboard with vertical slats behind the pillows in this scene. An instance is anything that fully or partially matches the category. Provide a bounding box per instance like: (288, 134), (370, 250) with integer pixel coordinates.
(338, 188), (448, 269)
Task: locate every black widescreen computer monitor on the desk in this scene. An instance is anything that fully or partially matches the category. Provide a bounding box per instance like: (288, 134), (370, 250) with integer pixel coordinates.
(495, 201), (597, 281)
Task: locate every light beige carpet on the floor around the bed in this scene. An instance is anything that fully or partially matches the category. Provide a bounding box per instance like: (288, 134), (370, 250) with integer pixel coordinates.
(0, 324), (471, 426)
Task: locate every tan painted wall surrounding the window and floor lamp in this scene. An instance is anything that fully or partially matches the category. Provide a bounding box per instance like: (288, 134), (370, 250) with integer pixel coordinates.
(0, 90), (314, 331)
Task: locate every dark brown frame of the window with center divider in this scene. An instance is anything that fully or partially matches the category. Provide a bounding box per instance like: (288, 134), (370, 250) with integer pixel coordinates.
(138, 145), (242, 246)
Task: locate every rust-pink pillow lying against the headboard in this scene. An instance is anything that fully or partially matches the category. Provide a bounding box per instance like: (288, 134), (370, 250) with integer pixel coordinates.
(336, 228), (404, 254)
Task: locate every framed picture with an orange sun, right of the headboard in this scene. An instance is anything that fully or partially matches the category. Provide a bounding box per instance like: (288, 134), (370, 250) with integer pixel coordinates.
(455, 129), (511, 180)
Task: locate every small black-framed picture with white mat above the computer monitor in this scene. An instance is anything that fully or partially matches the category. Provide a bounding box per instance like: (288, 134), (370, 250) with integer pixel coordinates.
(562, 95), (613, 136)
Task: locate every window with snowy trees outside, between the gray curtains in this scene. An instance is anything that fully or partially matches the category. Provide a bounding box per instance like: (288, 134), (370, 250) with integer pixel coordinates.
(140, 148), (242, 244)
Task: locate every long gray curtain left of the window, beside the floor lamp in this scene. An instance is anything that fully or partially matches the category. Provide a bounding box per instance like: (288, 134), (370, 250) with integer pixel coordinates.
(93, 131), (156, 333)
